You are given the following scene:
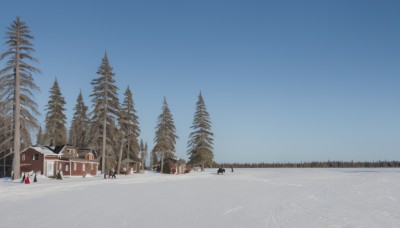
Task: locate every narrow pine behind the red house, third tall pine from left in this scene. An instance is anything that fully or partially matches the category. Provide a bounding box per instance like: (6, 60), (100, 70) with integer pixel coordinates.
(69, 91), (89, 149)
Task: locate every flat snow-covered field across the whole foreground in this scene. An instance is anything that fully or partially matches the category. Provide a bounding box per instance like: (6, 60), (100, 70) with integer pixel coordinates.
(0, 169), (400, 228)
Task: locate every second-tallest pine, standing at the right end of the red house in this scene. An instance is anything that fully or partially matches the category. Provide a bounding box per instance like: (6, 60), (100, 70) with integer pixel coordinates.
(90, 53), (119, 174)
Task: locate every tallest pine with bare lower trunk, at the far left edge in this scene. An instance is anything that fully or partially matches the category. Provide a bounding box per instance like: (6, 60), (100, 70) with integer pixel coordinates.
(0, 17), (40, 179)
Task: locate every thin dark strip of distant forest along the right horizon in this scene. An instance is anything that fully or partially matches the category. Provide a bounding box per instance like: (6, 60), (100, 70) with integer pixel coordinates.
(214, 161), (400, 168)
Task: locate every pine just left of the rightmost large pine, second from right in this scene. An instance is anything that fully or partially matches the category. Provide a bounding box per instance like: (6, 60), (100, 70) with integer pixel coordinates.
(154, 97), (178, 173)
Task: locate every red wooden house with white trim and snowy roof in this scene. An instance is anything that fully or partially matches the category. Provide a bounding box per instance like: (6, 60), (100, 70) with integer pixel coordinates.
(21, 145), (99, 177)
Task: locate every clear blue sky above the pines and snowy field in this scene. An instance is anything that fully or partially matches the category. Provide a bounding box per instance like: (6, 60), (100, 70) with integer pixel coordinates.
(0, 0), (400, 162)
